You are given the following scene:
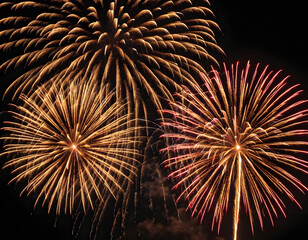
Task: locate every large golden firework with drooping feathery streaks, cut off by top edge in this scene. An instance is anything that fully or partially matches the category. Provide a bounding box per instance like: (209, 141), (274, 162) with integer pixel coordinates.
(0, 0), (222, 118)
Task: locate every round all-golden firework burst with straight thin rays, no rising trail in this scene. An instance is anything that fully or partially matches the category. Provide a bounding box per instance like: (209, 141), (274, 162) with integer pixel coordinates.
(2, 82), (138, 214)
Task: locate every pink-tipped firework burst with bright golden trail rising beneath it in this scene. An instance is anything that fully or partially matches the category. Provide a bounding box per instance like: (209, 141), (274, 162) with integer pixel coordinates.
(163, 62), (308, 239)
